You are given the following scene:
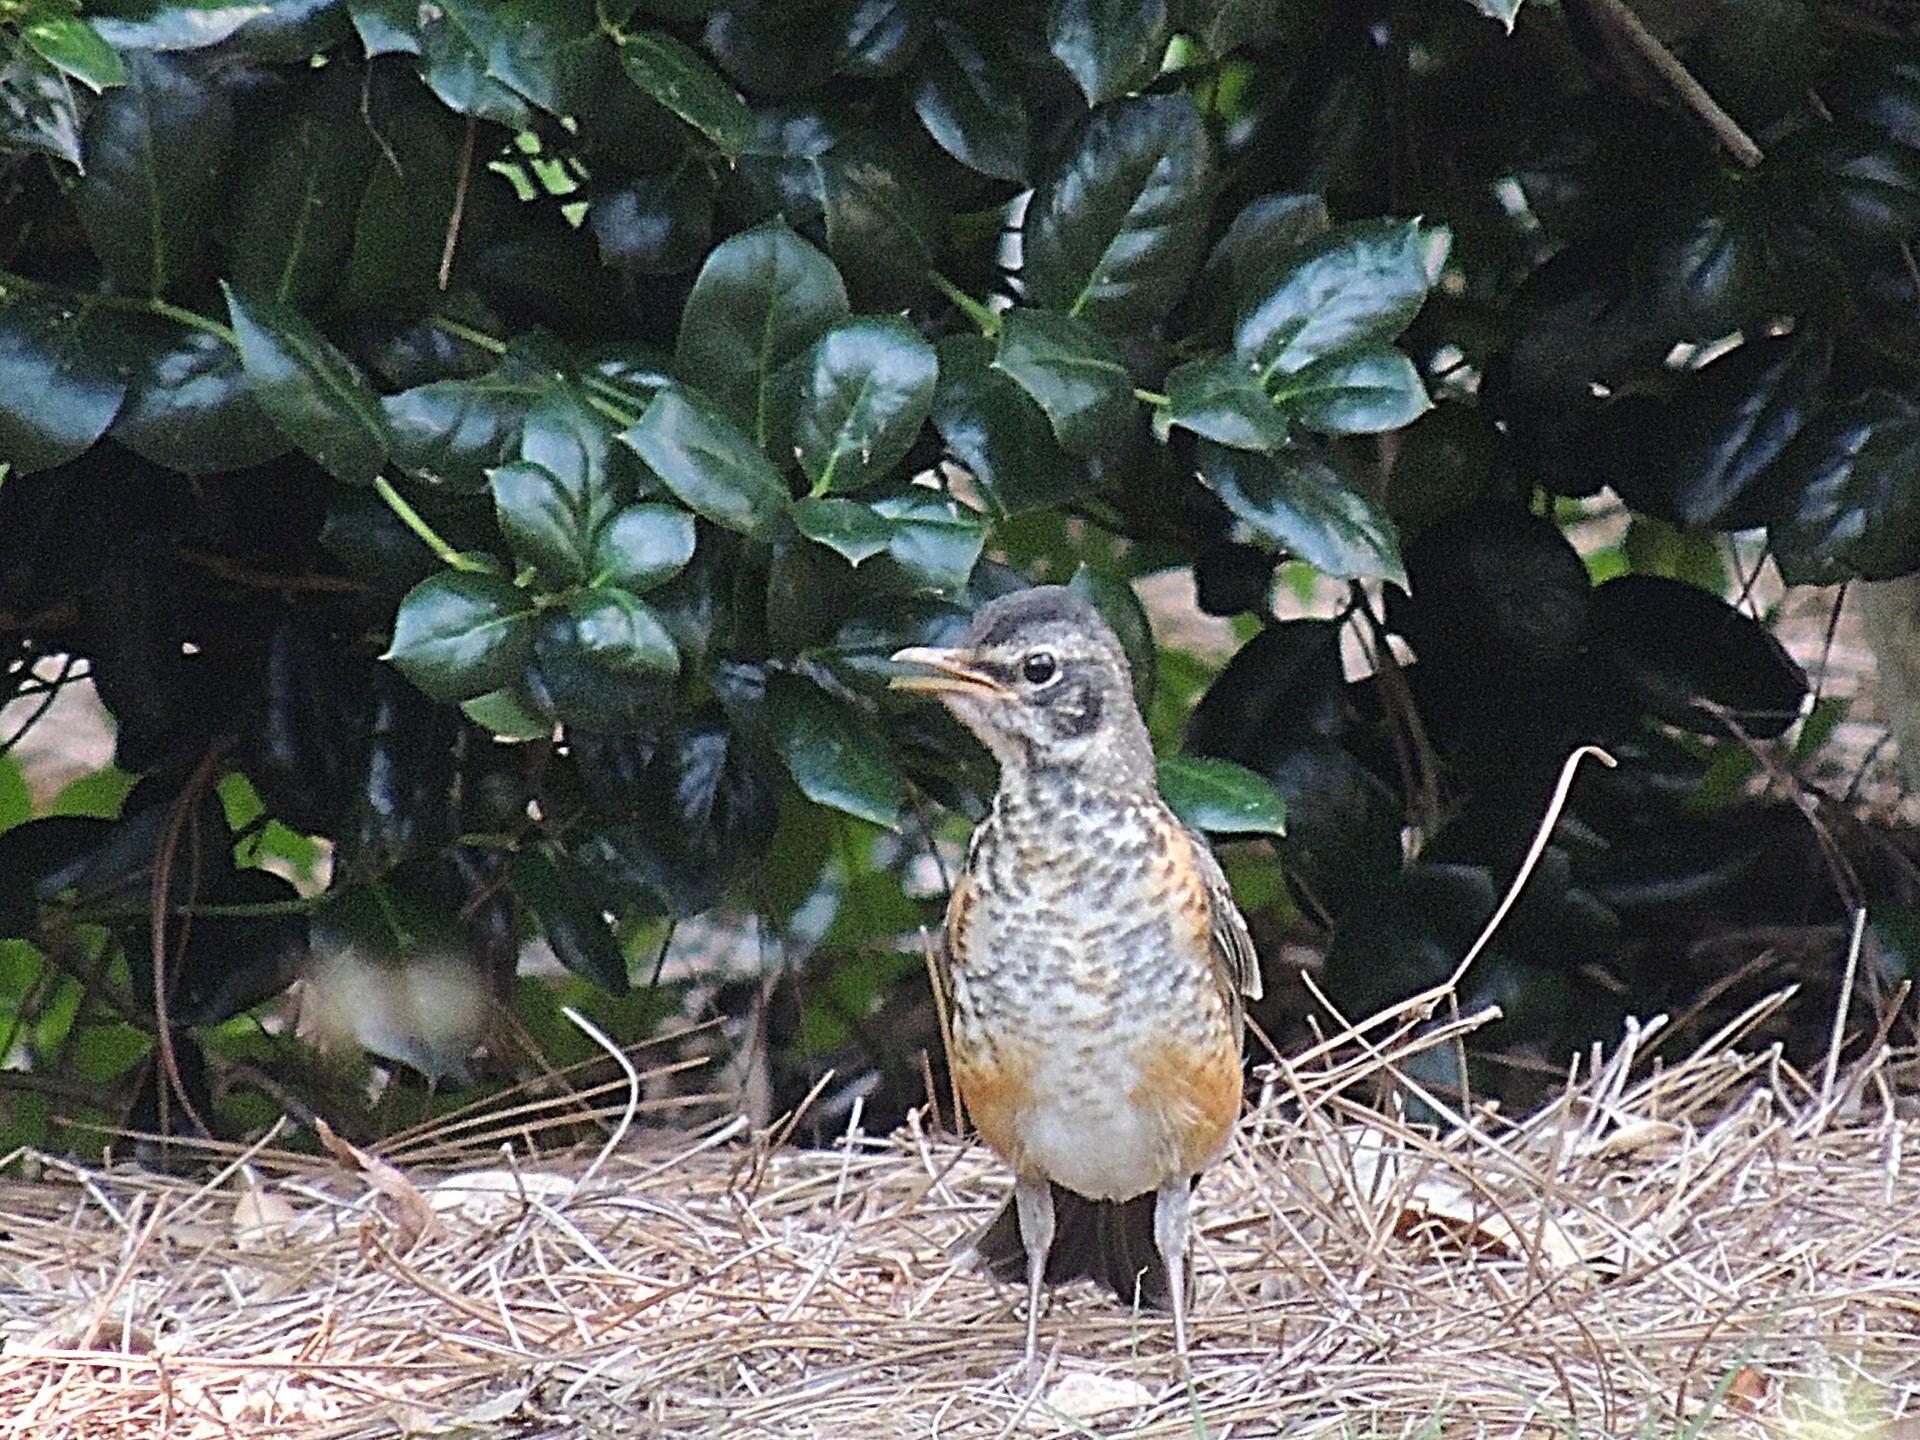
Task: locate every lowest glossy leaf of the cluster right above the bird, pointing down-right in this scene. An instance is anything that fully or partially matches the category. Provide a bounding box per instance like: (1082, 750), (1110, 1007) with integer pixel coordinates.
(1198, 442), (1407, 588)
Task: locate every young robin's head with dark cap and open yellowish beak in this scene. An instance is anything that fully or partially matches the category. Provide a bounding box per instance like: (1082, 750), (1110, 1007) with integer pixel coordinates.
(893, 586), (1154, 783)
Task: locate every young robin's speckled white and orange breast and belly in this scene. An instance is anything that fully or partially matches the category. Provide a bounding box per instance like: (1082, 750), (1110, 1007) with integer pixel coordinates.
(952, 770), (1240, 1200)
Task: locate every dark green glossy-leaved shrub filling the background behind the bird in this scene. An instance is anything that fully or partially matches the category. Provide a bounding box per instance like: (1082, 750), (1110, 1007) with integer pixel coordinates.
(0, 0), (1920, 1148)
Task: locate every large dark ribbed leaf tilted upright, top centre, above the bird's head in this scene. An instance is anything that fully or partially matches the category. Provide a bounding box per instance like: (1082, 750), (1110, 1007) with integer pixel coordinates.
(1021, 94), (1213, 334)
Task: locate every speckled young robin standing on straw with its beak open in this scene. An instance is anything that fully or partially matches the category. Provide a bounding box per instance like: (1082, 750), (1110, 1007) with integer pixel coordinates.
(893, 586), (1260, 1367)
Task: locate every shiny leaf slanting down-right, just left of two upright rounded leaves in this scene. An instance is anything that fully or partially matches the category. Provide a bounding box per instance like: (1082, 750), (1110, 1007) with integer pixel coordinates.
(620, 386), (787, 540)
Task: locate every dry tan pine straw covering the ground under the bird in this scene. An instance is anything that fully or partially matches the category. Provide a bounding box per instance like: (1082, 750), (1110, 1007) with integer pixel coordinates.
(0, 1004), (1920, 1440)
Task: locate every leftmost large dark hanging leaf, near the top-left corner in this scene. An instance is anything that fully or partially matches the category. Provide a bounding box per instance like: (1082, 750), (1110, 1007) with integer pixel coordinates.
(73, 50), (232, 296)
